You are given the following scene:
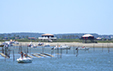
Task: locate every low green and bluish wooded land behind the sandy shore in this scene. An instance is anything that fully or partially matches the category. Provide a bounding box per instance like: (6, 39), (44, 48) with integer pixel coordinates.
(0, 33), (113, 43)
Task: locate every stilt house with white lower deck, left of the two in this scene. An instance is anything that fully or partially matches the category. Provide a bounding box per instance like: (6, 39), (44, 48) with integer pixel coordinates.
(38, 34), (57, 42)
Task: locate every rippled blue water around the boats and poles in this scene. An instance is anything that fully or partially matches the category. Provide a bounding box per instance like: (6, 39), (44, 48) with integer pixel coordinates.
(0, 47), (113, 71)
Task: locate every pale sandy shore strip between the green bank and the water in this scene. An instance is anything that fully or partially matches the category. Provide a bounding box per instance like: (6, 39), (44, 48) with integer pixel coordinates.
(0, 42), (113, 48)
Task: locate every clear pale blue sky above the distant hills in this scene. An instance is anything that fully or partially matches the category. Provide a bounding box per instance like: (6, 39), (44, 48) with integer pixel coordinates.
(0, 0), (113, 35)
